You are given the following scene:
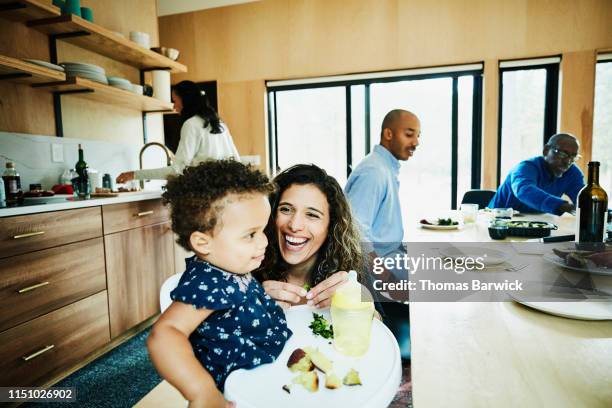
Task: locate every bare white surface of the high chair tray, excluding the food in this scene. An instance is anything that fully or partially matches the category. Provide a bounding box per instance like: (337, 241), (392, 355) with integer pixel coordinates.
(225, 305), (402, 408)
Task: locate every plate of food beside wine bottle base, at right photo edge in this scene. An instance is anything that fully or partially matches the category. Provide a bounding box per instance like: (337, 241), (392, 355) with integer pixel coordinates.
(544, 246), (612, 276)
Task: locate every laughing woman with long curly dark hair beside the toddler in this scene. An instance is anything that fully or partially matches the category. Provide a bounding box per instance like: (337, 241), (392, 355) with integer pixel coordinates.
(257, 164), (364, 308)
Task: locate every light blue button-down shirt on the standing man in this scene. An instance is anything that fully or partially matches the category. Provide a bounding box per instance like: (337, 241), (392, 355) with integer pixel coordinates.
(344, 145), (404, 243)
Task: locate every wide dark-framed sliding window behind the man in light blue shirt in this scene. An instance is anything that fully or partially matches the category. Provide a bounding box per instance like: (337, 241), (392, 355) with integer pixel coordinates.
(267, 64), (482, 221)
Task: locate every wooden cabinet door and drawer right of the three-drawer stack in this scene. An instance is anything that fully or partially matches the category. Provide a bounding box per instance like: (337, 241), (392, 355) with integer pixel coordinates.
(102, 200), (174, 338)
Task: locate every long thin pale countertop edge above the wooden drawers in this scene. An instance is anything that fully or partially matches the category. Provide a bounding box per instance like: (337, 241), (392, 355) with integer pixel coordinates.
(0, 190), (162, 218)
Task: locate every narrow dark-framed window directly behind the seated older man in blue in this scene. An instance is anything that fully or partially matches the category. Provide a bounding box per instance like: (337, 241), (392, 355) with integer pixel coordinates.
(497, 57), (560, 185)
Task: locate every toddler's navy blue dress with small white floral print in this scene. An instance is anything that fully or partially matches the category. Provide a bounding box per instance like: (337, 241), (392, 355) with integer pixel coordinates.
(170, 256), (292, 391)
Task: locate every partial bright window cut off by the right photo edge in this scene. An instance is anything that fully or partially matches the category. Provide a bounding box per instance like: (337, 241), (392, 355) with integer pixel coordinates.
(591, 54), (612, 194)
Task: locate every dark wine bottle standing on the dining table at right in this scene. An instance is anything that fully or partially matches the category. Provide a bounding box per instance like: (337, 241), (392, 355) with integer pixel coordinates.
(576, 162), (608, 250)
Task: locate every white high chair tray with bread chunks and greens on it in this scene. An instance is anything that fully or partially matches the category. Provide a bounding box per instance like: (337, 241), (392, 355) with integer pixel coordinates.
(224, 305), (401, 408)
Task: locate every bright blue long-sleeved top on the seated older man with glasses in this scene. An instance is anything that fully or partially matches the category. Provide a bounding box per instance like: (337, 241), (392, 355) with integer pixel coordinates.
(489, 156), (584, 215)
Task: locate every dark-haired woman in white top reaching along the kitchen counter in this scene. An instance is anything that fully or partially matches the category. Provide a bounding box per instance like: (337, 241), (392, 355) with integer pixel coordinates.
(117, 81), (240, 183)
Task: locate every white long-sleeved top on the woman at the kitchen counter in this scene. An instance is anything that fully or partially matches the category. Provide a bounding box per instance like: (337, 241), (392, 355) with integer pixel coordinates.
(134, 115), (240, 180)
